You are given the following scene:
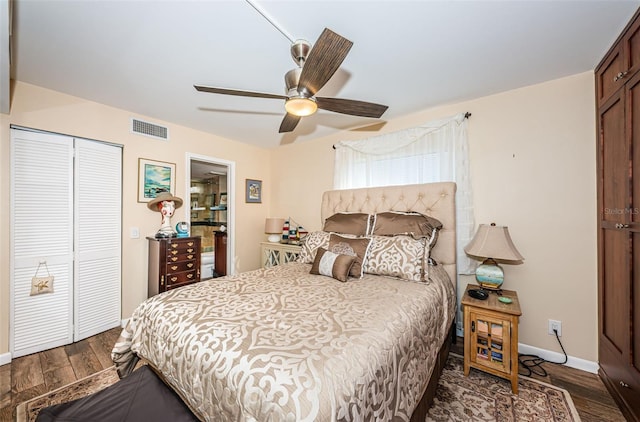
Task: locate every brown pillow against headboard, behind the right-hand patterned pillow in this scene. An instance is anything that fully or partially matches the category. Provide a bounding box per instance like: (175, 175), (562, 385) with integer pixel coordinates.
(372, 211), (442, 247)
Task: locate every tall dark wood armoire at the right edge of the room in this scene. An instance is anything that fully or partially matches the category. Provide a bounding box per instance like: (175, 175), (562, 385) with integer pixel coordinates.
(595, 8), (640, 421)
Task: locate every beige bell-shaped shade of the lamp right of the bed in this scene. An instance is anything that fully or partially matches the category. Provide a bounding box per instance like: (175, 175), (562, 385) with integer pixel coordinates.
(464, 223), (524, 261)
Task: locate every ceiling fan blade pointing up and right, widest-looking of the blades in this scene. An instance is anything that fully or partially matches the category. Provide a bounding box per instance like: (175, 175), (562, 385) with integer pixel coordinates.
(298, 28), (353, 96)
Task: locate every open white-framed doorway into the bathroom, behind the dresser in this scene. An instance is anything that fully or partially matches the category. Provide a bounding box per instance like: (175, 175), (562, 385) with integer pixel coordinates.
(185, 154), (235, 280)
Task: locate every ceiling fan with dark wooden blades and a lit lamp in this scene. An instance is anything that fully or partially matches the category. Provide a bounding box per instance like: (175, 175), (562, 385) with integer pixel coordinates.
(194, 28), (388, 133)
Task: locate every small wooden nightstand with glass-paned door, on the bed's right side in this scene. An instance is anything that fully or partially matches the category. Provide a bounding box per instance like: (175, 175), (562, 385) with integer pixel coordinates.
(461, 284), (522, 394)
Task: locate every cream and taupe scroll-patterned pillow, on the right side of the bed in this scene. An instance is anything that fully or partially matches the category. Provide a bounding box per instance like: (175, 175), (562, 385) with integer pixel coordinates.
(364, 235), (429, 281)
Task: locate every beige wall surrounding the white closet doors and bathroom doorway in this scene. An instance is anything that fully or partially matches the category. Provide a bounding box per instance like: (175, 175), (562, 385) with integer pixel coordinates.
(0, 83), (271, 355)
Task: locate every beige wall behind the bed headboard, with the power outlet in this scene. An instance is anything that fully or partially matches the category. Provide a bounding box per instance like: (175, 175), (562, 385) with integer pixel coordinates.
(271, 72), (598, 361)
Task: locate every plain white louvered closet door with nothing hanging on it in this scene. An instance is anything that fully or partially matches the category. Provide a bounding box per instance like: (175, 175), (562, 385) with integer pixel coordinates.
(74, 139), (122, 341)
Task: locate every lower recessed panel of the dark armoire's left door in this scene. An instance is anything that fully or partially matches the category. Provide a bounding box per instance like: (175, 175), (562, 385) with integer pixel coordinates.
(601, 230), (631, 353)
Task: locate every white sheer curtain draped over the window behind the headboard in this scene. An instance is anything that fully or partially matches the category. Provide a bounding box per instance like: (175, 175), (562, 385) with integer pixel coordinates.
(333, 113), (475, 274)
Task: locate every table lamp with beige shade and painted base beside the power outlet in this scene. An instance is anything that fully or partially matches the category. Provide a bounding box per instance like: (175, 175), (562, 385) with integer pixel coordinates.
(464, 223), (524, 290)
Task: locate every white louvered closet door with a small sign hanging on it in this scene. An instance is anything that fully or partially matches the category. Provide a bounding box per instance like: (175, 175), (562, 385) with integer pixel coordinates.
(10, 129), (73, 357)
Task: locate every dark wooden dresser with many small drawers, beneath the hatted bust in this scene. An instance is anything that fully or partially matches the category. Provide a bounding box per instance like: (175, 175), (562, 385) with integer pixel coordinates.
(147, 237), (200, 297)
